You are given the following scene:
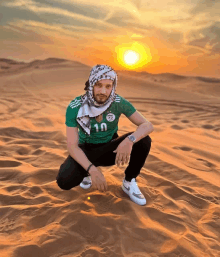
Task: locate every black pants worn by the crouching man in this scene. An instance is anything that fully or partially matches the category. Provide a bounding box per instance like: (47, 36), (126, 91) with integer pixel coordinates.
(56, 131), (151, 190)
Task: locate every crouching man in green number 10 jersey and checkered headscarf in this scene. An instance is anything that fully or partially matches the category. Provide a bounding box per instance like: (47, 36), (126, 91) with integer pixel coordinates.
(56, 65), (154, 205)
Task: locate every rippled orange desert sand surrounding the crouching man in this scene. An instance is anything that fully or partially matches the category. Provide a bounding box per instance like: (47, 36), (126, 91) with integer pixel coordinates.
(0, 58), (220, 257)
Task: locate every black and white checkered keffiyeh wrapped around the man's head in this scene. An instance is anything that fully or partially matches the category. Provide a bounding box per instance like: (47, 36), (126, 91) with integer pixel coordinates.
(77, 64), (118, 136)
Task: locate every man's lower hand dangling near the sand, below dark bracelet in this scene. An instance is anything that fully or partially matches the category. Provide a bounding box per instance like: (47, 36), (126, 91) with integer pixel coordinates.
(89, 165), (108, 192)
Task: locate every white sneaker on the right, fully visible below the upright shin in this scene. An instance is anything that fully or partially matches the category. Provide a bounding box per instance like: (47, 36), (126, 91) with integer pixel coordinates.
(122, 178), (147, 205)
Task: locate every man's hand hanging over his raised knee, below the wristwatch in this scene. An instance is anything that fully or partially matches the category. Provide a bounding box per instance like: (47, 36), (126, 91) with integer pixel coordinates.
(113, 138), (133, 166)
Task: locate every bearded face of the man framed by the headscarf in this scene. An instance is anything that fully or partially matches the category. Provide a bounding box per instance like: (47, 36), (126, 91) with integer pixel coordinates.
(93, 79), (113, 104)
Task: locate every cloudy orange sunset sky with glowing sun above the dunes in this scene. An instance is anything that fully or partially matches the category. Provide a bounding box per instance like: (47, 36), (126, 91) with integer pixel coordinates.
(0, 0), (220, 78)
